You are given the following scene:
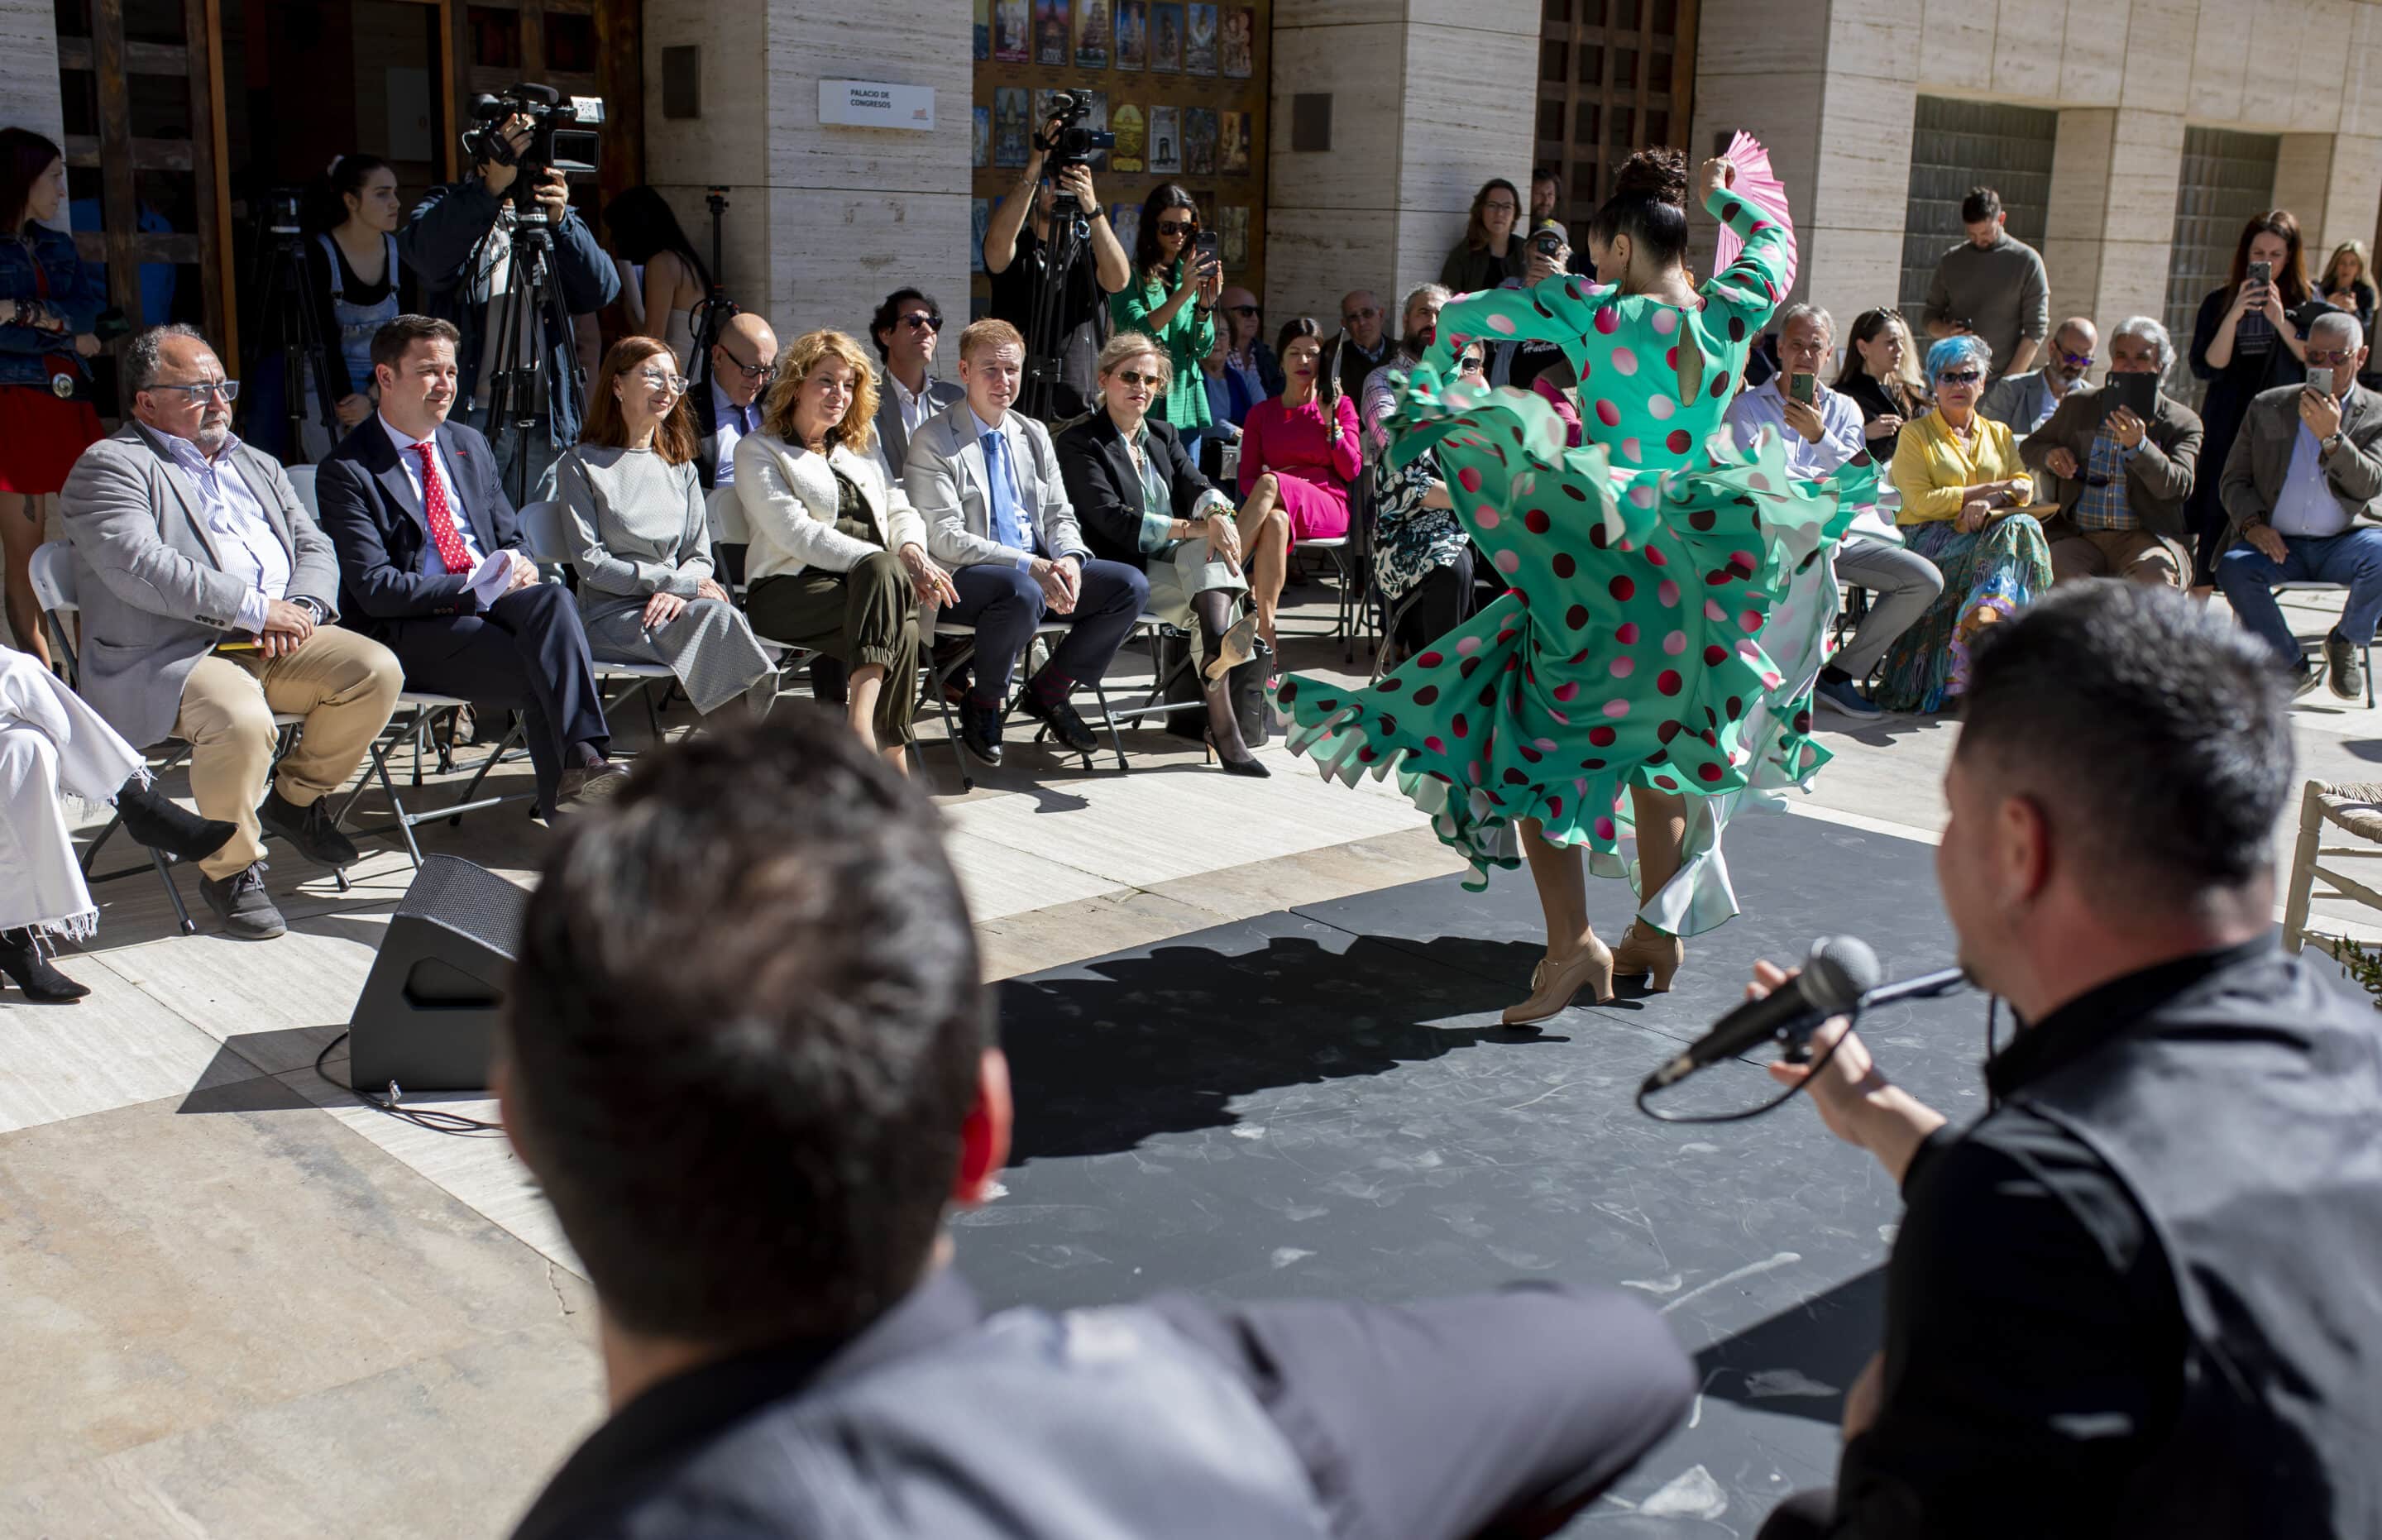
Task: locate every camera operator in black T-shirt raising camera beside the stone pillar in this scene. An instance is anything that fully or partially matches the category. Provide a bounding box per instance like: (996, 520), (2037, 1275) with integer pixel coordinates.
(983, 117), (1134, 419)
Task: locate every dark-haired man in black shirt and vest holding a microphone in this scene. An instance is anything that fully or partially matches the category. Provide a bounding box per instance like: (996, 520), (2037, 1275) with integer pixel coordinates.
(1756, 583), (2382, 1540)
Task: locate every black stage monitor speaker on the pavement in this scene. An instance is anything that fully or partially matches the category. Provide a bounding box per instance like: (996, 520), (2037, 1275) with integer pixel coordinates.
(347, 854), (529, 1093)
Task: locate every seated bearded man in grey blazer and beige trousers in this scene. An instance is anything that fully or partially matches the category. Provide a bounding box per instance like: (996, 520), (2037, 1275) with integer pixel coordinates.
(60, 326), (405, 940)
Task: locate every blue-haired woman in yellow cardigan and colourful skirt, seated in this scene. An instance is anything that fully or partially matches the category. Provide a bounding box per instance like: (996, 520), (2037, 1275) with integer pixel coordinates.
(1875, 336), (2051, 711)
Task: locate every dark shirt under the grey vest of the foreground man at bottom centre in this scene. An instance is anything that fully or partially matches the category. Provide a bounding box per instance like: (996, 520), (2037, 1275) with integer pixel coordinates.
(514, 1269), (1694, 1540)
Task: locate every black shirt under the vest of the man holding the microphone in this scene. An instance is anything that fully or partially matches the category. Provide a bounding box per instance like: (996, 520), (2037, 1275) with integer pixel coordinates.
(1830, 938), (2273, 1540)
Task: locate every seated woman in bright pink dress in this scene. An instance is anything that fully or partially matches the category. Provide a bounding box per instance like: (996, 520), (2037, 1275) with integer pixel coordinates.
(1241, 317), (1360, 657)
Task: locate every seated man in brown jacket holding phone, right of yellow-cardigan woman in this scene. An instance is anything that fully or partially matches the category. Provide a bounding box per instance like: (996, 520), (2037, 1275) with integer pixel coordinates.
(2017, 317), (2201, 588)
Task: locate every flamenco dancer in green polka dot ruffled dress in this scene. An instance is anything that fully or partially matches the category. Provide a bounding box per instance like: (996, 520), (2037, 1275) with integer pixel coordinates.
(1275, 150), (1877, 1026)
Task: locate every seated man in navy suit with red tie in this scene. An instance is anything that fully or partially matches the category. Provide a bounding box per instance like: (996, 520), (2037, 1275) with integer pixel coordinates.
(314, 317), (626, 814)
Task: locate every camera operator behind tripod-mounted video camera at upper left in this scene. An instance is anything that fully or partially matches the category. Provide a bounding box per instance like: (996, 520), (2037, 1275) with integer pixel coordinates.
(398, 114), (619, 485)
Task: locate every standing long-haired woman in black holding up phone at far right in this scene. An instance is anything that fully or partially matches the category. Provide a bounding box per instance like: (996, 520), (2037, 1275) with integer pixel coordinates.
(2189, 209), (2332, 588)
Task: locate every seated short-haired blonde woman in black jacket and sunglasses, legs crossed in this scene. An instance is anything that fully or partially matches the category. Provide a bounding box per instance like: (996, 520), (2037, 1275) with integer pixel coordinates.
(1053, 331), (1270, 776)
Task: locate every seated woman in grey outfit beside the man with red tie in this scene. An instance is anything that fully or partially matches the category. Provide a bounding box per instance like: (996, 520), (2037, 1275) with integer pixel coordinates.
(555, 336), (777, 716)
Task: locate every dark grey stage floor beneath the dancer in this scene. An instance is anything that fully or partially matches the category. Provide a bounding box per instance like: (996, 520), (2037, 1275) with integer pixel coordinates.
(958, 816), (2008, 1535)
